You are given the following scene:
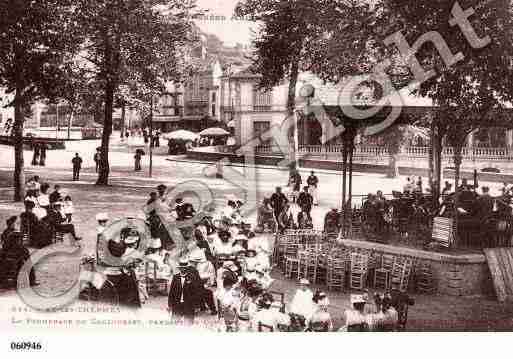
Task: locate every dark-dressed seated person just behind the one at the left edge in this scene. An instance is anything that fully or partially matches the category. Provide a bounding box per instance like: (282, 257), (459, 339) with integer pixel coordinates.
(20, 201), (53, 248)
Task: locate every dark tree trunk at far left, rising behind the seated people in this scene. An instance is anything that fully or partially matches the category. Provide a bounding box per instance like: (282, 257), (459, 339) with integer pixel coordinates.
(12, 94), (25, 202)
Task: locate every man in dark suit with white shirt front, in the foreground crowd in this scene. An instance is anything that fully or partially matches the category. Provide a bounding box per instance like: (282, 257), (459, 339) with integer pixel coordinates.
(168, 261), (202, 324)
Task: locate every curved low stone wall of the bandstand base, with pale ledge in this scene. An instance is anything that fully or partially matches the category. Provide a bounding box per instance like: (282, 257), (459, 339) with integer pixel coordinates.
(342, 240), (495, 296)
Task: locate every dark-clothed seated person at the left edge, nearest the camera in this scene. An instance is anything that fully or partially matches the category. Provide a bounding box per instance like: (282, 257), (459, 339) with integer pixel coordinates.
(0, 232), (38, 287)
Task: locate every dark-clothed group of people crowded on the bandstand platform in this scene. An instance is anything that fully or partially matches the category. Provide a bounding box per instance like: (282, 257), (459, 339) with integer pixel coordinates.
(356, 177), (513, 246)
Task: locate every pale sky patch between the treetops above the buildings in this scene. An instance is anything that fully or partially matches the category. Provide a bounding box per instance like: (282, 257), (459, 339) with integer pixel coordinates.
(196, 0), (256, 46)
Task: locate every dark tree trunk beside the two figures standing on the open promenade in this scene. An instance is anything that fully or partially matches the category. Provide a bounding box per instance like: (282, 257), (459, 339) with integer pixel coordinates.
(96, 83), (114, 186)
